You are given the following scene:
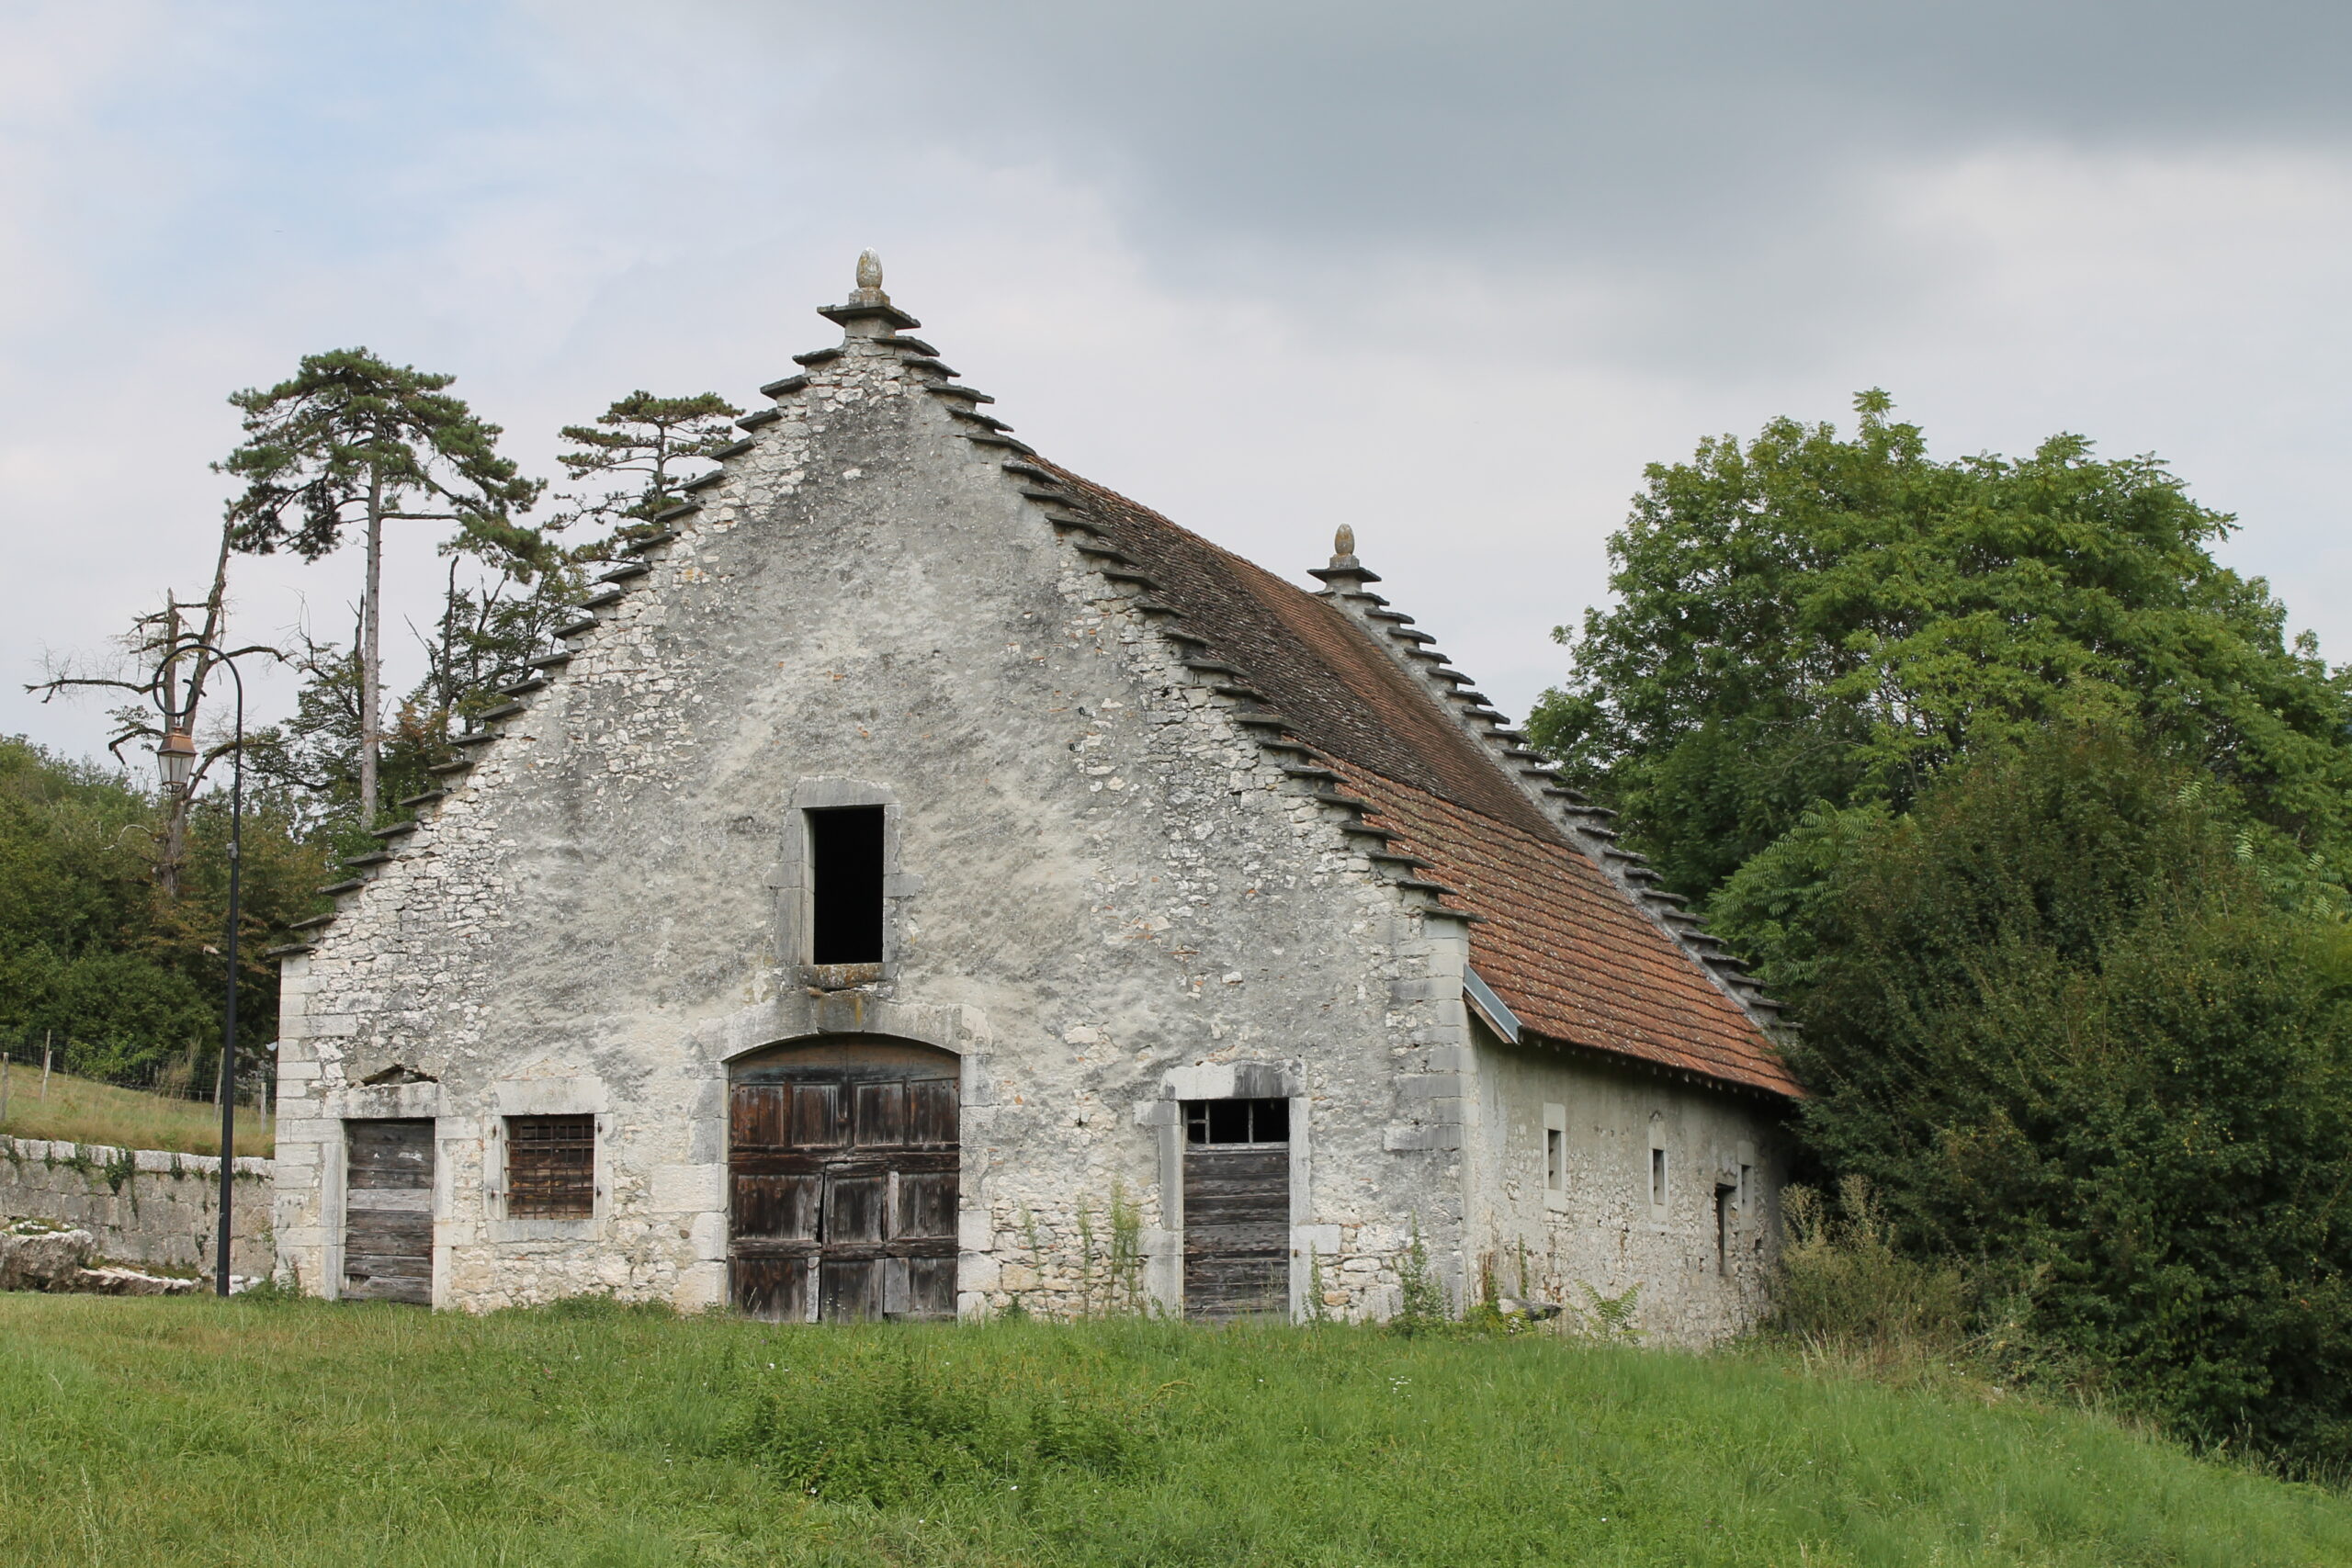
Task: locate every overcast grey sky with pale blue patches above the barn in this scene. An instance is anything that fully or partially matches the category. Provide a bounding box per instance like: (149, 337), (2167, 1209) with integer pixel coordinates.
(0, 0), (2352, 771)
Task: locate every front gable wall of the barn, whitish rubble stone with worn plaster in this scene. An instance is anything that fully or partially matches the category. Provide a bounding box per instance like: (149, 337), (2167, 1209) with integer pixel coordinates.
(277, 320), (1465, 1314)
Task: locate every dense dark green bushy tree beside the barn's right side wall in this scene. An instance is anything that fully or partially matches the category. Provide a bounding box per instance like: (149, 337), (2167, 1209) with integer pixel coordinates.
(1717, 727), (2352, 1472)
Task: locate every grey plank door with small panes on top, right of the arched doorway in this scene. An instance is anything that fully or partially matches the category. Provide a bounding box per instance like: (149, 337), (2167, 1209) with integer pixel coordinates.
(1183, 1100), (1291, 1319)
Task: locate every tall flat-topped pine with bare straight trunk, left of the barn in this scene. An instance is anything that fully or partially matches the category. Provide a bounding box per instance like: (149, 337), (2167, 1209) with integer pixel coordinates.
(217, 348), (548, 823)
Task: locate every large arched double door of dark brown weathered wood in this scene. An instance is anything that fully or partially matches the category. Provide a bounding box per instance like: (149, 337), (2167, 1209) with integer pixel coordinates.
(727, 1043), (962, 1324)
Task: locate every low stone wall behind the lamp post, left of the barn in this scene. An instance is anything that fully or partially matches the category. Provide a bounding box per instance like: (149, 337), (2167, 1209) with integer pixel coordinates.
(0, 1138), (276, 1277)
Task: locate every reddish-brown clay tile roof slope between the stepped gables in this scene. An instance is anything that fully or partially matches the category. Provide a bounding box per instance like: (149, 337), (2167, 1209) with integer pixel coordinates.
(1054, 468), (1802, 1096)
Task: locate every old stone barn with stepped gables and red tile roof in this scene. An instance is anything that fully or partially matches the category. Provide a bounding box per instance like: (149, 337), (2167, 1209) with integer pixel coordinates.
(262, 261), (1794, 1342)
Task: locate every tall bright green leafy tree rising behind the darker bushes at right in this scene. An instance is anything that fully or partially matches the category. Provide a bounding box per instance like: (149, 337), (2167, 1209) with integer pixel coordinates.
(1529, 392), (2352, 898)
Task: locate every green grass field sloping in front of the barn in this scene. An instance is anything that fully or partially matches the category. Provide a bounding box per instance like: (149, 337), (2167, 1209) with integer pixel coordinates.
(0, 1295), (2352, 1568)
